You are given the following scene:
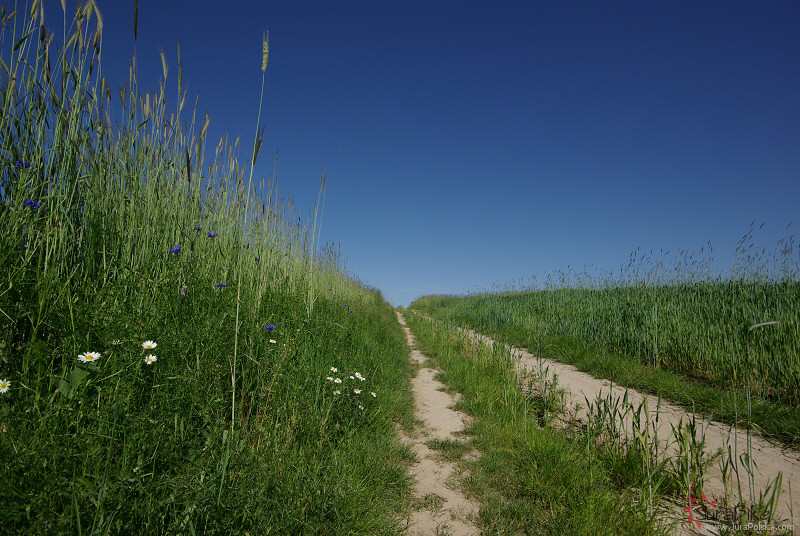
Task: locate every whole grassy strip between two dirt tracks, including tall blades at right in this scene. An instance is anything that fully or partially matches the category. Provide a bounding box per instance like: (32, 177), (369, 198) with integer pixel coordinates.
(406, 311), (794, 535)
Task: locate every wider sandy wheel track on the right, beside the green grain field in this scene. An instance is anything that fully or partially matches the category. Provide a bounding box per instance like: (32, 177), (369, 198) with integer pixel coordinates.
(465, 322), (800, 533)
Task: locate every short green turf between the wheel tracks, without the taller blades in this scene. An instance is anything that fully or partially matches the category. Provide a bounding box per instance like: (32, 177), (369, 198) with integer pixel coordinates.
(406, 312), (664, 535)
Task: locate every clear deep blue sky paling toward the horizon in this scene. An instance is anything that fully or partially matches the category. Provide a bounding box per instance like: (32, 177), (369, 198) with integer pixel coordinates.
(45, 0), (800, 305)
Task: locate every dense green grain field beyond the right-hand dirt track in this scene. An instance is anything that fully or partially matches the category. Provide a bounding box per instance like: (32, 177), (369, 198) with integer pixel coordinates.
(410, 234), (800, 446)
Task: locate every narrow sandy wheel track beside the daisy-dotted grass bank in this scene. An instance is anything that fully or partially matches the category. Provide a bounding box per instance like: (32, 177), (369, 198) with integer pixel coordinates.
(397, 312), (480, 536)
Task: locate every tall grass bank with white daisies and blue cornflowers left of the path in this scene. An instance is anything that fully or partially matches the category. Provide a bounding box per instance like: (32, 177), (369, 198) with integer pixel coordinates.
(0, 1), (411, 534)
